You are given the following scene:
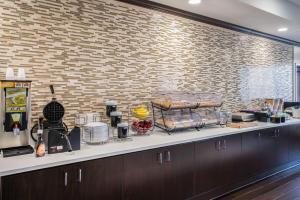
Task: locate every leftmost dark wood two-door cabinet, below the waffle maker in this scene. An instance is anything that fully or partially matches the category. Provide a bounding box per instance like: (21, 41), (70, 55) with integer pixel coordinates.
(2, 157), (123, 200)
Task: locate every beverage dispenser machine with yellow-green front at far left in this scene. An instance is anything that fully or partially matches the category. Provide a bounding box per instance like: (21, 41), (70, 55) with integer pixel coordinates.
(0, 80), (33, 157)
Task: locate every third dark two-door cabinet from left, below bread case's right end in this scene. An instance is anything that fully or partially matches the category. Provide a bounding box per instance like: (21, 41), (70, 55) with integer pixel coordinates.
(195, 134), (241, 195)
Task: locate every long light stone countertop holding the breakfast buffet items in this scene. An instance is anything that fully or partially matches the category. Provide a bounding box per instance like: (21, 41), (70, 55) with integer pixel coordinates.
(0, 119), (300, 177)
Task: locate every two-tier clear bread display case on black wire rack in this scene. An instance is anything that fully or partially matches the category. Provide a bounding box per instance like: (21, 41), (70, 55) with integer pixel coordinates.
(151, 91), (225, 133)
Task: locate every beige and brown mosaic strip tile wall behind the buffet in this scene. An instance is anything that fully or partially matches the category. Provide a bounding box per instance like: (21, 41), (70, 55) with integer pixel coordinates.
(0, 0), (293, 124)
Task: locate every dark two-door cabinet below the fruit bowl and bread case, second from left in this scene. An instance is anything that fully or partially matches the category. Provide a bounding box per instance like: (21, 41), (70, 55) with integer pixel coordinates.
(124, 143), (194, 200)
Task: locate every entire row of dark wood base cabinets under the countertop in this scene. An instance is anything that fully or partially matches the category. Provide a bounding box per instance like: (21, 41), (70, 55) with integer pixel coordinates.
(0, 125), (300, 200)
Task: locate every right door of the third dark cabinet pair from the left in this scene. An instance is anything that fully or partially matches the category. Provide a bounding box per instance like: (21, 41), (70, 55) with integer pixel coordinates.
(220, 134), (242, 185)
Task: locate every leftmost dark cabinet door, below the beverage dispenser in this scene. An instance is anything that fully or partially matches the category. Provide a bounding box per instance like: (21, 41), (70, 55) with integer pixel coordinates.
(2, 166), (72, 200)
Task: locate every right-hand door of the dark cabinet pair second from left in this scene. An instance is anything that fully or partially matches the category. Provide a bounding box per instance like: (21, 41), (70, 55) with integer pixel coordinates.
(163, 143), (195, 200)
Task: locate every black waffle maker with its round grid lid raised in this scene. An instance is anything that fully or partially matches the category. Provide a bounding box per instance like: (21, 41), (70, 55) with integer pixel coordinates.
(31, 85), (80, 154)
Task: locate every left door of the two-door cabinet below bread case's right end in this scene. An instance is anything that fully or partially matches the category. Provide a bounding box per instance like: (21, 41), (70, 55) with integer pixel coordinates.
(195, 138), (222, 195)
